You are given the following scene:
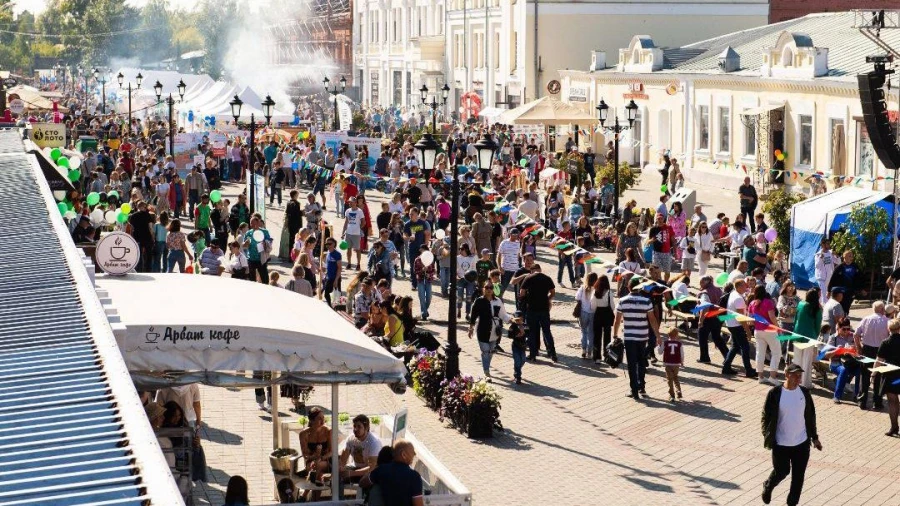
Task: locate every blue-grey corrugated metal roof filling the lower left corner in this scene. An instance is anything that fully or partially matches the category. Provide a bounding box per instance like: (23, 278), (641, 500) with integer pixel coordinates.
(0, 131), (183, 506)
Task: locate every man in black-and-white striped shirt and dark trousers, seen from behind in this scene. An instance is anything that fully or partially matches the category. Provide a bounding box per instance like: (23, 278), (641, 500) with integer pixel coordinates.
(613, 278), (659, 399)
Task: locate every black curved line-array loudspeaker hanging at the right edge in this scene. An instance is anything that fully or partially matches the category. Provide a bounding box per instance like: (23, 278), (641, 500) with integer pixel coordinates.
(856, 70), (900, 170)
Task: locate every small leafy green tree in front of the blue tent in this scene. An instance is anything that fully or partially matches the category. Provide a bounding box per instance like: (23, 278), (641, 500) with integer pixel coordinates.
(831, 205), (894, 293)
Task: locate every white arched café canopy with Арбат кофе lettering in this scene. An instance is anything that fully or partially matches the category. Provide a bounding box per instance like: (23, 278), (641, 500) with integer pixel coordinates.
(97, 274), (406, 386)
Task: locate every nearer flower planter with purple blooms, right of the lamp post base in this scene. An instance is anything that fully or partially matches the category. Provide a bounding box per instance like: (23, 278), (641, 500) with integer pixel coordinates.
(440, 376), (503, 438)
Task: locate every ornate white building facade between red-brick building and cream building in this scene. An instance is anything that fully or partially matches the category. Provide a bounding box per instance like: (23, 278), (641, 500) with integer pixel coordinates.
(353, 0), (446, 106)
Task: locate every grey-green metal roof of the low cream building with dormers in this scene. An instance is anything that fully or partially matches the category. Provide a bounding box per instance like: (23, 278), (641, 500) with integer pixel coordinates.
(607, 12), (900, 81)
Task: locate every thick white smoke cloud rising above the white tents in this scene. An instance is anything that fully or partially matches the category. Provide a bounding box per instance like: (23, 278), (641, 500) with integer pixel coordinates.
(223, 0), (337, 113)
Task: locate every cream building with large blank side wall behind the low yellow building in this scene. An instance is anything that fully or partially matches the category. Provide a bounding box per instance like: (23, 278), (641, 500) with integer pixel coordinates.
(442, 0), (769, 109)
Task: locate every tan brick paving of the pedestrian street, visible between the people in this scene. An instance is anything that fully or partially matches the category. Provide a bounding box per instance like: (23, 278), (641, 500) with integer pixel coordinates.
(188, 174), (900, 505)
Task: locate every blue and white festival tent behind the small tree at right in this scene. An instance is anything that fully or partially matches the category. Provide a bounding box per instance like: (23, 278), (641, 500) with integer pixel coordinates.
(790, 186), (894, 290)
